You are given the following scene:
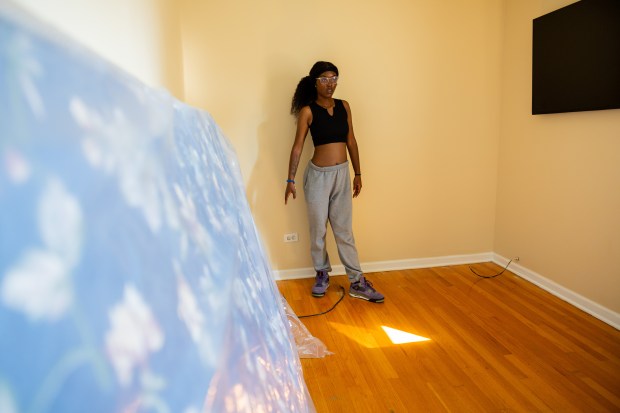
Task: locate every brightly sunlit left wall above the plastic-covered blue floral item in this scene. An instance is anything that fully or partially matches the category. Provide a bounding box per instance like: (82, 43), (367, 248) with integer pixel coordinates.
(14, 0), (183, 99)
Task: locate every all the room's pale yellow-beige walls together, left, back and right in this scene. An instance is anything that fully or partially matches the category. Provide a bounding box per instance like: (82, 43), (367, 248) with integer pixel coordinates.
(8, 0), (620, 312)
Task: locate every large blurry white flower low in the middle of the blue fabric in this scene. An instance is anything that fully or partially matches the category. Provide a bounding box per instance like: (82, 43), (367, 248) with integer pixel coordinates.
(105, 285), (164, 387)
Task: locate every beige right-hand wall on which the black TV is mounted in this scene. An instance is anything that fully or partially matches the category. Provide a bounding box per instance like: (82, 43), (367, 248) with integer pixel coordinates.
(494, 0), (620, 312)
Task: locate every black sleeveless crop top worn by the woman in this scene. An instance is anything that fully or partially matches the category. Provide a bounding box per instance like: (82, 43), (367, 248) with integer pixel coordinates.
(310, 99), (349, 146)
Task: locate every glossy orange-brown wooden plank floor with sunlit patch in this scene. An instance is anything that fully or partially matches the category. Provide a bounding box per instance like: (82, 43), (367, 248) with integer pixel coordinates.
(278, 263), (620, 413)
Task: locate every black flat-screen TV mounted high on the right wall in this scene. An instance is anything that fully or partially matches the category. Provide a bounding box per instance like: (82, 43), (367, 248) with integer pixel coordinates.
(532, 0), (620, 115)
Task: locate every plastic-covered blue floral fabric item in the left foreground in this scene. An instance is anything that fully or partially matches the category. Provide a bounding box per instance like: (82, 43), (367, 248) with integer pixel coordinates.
(0, 4), (314, 413)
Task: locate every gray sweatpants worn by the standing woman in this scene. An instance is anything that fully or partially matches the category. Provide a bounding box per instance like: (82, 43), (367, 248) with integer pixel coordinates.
(304, 161), (362, 282)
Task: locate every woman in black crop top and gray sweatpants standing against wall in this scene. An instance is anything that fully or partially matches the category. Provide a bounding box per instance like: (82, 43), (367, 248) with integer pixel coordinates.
(284, 62), (384, 303)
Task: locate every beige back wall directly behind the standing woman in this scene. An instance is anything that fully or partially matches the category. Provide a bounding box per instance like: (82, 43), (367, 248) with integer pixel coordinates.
(182, 0), (502, 275)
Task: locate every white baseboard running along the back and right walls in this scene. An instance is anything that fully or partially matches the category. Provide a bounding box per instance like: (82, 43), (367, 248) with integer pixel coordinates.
(272, 252), (620, 330)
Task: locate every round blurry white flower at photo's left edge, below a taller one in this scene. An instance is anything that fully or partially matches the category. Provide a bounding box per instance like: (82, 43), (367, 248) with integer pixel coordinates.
(1, 250), (73, 321)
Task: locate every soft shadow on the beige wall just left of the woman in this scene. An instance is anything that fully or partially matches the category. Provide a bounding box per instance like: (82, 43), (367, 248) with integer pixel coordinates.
(246, 56), (313, 270)
